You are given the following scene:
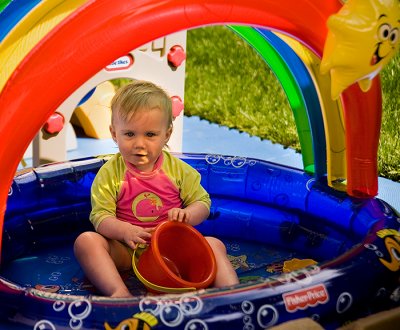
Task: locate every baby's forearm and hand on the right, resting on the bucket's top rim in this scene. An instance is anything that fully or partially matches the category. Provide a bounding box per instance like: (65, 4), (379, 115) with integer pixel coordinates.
(168, 201), (210, 226)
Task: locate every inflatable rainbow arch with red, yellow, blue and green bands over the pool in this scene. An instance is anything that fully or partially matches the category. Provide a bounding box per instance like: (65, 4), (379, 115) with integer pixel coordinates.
(0, 0), (399, 258)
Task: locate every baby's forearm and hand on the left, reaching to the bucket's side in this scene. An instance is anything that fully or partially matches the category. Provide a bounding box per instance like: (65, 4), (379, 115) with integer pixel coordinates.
(97, 216), (154, 249)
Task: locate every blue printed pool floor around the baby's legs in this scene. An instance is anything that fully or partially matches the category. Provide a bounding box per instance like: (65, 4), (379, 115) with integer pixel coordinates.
(0, 239), (307, 295)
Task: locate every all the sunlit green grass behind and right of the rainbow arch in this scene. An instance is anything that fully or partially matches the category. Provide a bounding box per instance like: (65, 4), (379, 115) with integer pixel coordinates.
(185, 26), (400, 181)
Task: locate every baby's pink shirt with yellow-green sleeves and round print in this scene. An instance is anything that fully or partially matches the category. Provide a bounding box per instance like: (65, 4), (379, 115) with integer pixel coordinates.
(90, 151), (211, 230)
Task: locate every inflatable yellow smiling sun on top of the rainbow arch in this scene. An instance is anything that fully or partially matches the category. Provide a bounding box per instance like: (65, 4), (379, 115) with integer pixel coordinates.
(321, 0), (400, 100)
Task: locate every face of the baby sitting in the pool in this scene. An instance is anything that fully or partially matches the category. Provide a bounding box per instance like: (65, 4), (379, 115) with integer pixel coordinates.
(110, 108), (172, 172)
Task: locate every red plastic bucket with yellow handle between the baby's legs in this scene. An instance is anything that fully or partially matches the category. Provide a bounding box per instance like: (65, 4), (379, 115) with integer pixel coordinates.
(132, 221), (217, 293)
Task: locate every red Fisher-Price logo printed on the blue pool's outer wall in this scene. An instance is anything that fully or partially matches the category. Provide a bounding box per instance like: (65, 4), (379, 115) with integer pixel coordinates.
(282, 284), (329, 313)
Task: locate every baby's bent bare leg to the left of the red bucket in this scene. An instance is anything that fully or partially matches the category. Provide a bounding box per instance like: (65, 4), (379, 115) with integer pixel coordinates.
(74, 232), (132, 298)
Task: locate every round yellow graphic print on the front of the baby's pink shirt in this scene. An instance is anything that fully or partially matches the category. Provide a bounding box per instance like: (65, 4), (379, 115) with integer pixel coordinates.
(132, 191), (164, 222)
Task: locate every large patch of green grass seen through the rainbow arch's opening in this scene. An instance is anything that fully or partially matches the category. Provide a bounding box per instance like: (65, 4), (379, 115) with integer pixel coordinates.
(185, 26), (300, 150)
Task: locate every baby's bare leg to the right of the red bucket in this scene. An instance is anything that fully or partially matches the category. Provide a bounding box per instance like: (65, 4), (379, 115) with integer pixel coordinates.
(206, 237), (239, 288)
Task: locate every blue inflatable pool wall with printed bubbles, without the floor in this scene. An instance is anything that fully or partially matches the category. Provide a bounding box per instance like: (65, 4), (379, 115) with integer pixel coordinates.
(0, 154), (400, 329)
